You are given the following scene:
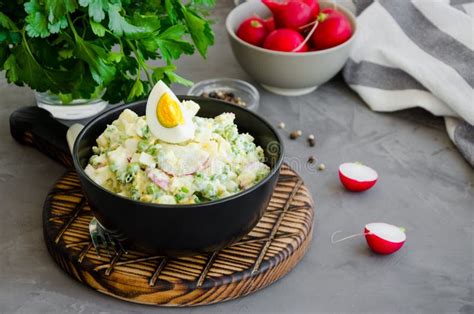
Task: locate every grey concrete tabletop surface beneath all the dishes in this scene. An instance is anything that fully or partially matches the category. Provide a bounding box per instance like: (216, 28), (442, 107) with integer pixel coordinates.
(0, 0), (474, 313)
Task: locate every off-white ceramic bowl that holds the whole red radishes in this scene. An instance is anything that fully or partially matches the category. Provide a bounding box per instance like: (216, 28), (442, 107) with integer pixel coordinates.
(226, 1), (357, 96)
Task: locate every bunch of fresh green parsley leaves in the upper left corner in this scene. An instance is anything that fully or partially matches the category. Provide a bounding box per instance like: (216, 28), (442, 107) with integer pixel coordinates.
(0, 0), (215, 103)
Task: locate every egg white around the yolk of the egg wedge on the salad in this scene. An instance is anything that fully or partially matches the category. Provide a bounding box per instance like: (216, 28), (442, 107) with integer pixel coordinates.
(146, 81), (199, 144)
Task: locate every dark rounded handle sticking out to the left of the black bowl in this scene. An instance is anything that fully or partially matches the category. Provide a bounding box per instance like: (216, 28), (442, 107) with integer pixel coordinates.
(10, 107), (73, 168)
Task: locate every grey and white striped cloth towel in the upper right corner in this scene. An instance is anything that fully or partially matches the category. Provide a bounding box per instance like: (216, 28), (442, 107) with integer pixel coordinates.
(343, 0), (474, 167)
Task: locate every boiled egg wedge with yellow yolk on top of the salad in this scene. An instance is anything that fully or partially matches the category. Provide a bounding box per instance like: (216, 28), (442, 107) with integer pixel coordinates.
(146, 81), (199, 144)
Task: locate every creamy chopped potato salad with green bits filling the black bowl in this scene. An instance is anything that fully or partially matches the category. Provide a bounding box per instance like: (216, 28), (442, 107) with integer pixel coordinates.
(85, 106), (270, 204)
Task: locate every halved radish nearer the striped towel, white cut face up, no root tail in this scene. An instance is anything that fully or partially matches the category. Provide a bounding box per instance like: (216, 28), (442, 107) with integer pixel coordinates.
(339, 162), (379, 192)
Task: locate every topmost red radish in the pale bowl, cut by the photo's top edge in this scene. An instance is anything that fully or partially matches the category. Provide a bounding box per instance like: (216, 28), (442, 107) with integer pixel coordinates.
(262, 0), (314, 30)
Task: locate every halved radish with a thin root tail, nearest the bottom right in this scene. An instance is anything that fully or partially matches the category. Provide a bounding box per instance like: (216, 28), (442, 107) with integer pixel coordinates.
(364, 222), (407, 254)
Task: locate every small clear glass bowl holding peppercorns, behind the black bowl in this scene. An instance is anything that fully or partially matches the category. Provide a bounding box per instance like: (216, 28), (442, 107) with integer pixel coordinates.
(188, 78), (260, 111)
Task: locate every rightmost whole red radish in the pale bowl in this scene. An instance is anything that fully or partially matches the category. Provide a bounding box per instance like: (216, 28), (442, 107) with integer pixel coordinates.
(311, 8), (352, 50)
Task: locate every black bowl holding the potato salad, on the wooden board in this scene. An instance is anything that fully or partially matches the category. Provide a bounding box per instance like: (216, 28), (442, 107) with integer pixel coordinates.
(72, 96), (283, 255)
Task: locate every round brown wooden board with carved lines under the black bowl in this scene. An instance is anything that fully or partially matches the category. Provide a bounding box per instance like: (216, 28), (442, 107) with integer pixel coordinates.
(43, 165), (314, 306)
